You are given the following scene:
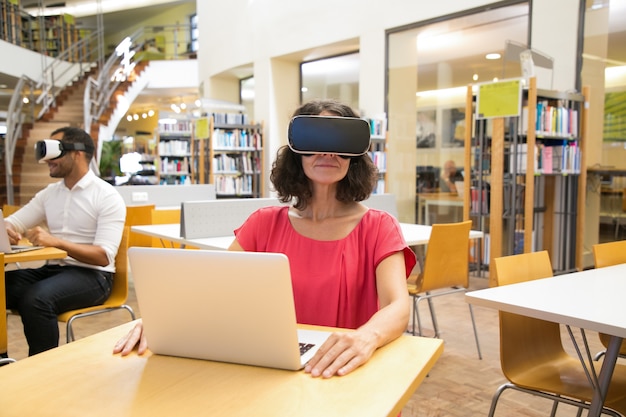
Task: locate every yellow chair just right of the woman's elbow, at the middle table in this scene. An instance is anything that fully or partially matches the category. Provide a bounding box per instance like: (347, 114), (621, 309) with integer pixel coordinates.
(407, 220), (482, 359)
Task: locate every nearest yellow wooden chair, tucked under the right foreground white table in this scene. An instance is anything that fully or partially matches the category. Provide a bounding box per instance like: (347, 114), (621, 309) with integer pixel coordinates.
(489, 251), (626, 417)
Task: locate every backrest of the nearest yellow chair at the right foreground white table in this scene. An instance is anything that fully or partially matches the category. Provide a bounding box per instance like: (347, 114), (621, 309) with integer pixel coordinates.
(494, 251), (566, 382)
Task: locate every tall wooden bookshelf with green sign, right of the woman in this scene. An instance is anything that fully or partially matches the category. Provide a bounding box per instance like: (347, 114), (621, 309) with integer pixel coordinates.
(464, 78), (587, 285)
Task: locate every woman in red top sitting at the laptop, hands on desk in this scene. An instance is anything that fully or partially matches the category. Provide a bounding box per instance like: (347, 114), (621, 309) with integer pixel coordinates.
(113, 100), (416, 378)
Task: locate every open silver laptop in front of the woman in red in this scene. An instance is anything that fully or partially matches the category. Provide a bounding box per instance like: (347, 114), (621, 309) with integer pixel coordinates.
(128, 247), (330, 370)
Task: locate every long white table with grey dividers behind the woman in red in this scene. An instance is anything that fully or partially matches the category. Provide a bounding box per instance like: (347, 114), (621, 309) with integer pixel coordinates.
(131, 223), (483, 250)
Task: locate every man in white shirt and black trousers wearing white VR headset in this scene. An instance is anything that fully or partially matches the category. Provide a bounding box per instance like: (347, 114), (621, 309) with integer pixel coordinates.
(5, 127), (126, 355)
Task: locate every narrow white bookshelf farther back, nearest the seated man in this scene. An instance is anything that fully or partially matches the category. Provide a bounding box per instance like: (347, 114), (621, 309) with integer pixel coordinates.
(156, 119), (193, 185)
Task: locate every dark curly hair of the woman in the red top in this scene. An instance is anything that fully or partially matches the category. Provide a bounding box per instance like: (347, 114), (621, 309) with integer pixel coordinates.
(270, 100), (378, 210)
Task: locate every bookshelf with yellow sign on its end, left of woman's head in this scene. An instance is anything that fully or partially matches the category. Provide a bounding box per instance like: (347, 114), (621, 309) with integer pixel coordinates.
(192, 113), (263, 198)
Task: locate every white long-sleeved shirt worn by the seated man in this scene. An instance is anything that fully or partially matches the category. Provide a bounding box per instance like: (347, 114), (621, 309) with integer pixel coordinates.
(6, 171), (126, 272)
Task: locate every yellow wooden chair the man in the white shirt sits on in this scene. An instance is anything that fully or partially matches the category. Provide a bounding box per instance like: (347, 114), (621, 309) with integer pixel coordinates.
(58, 226), (135, 343)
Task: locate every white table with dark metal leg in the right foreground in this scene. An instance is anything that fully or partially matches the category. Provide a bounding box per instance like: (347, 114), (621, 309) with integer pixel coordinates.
(465, 264), (626, 417)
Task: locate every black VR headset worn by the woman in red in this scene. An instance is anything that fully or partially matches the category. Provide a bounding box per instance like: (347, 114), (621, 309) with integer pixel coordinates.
(289, 116), (370, 156)
